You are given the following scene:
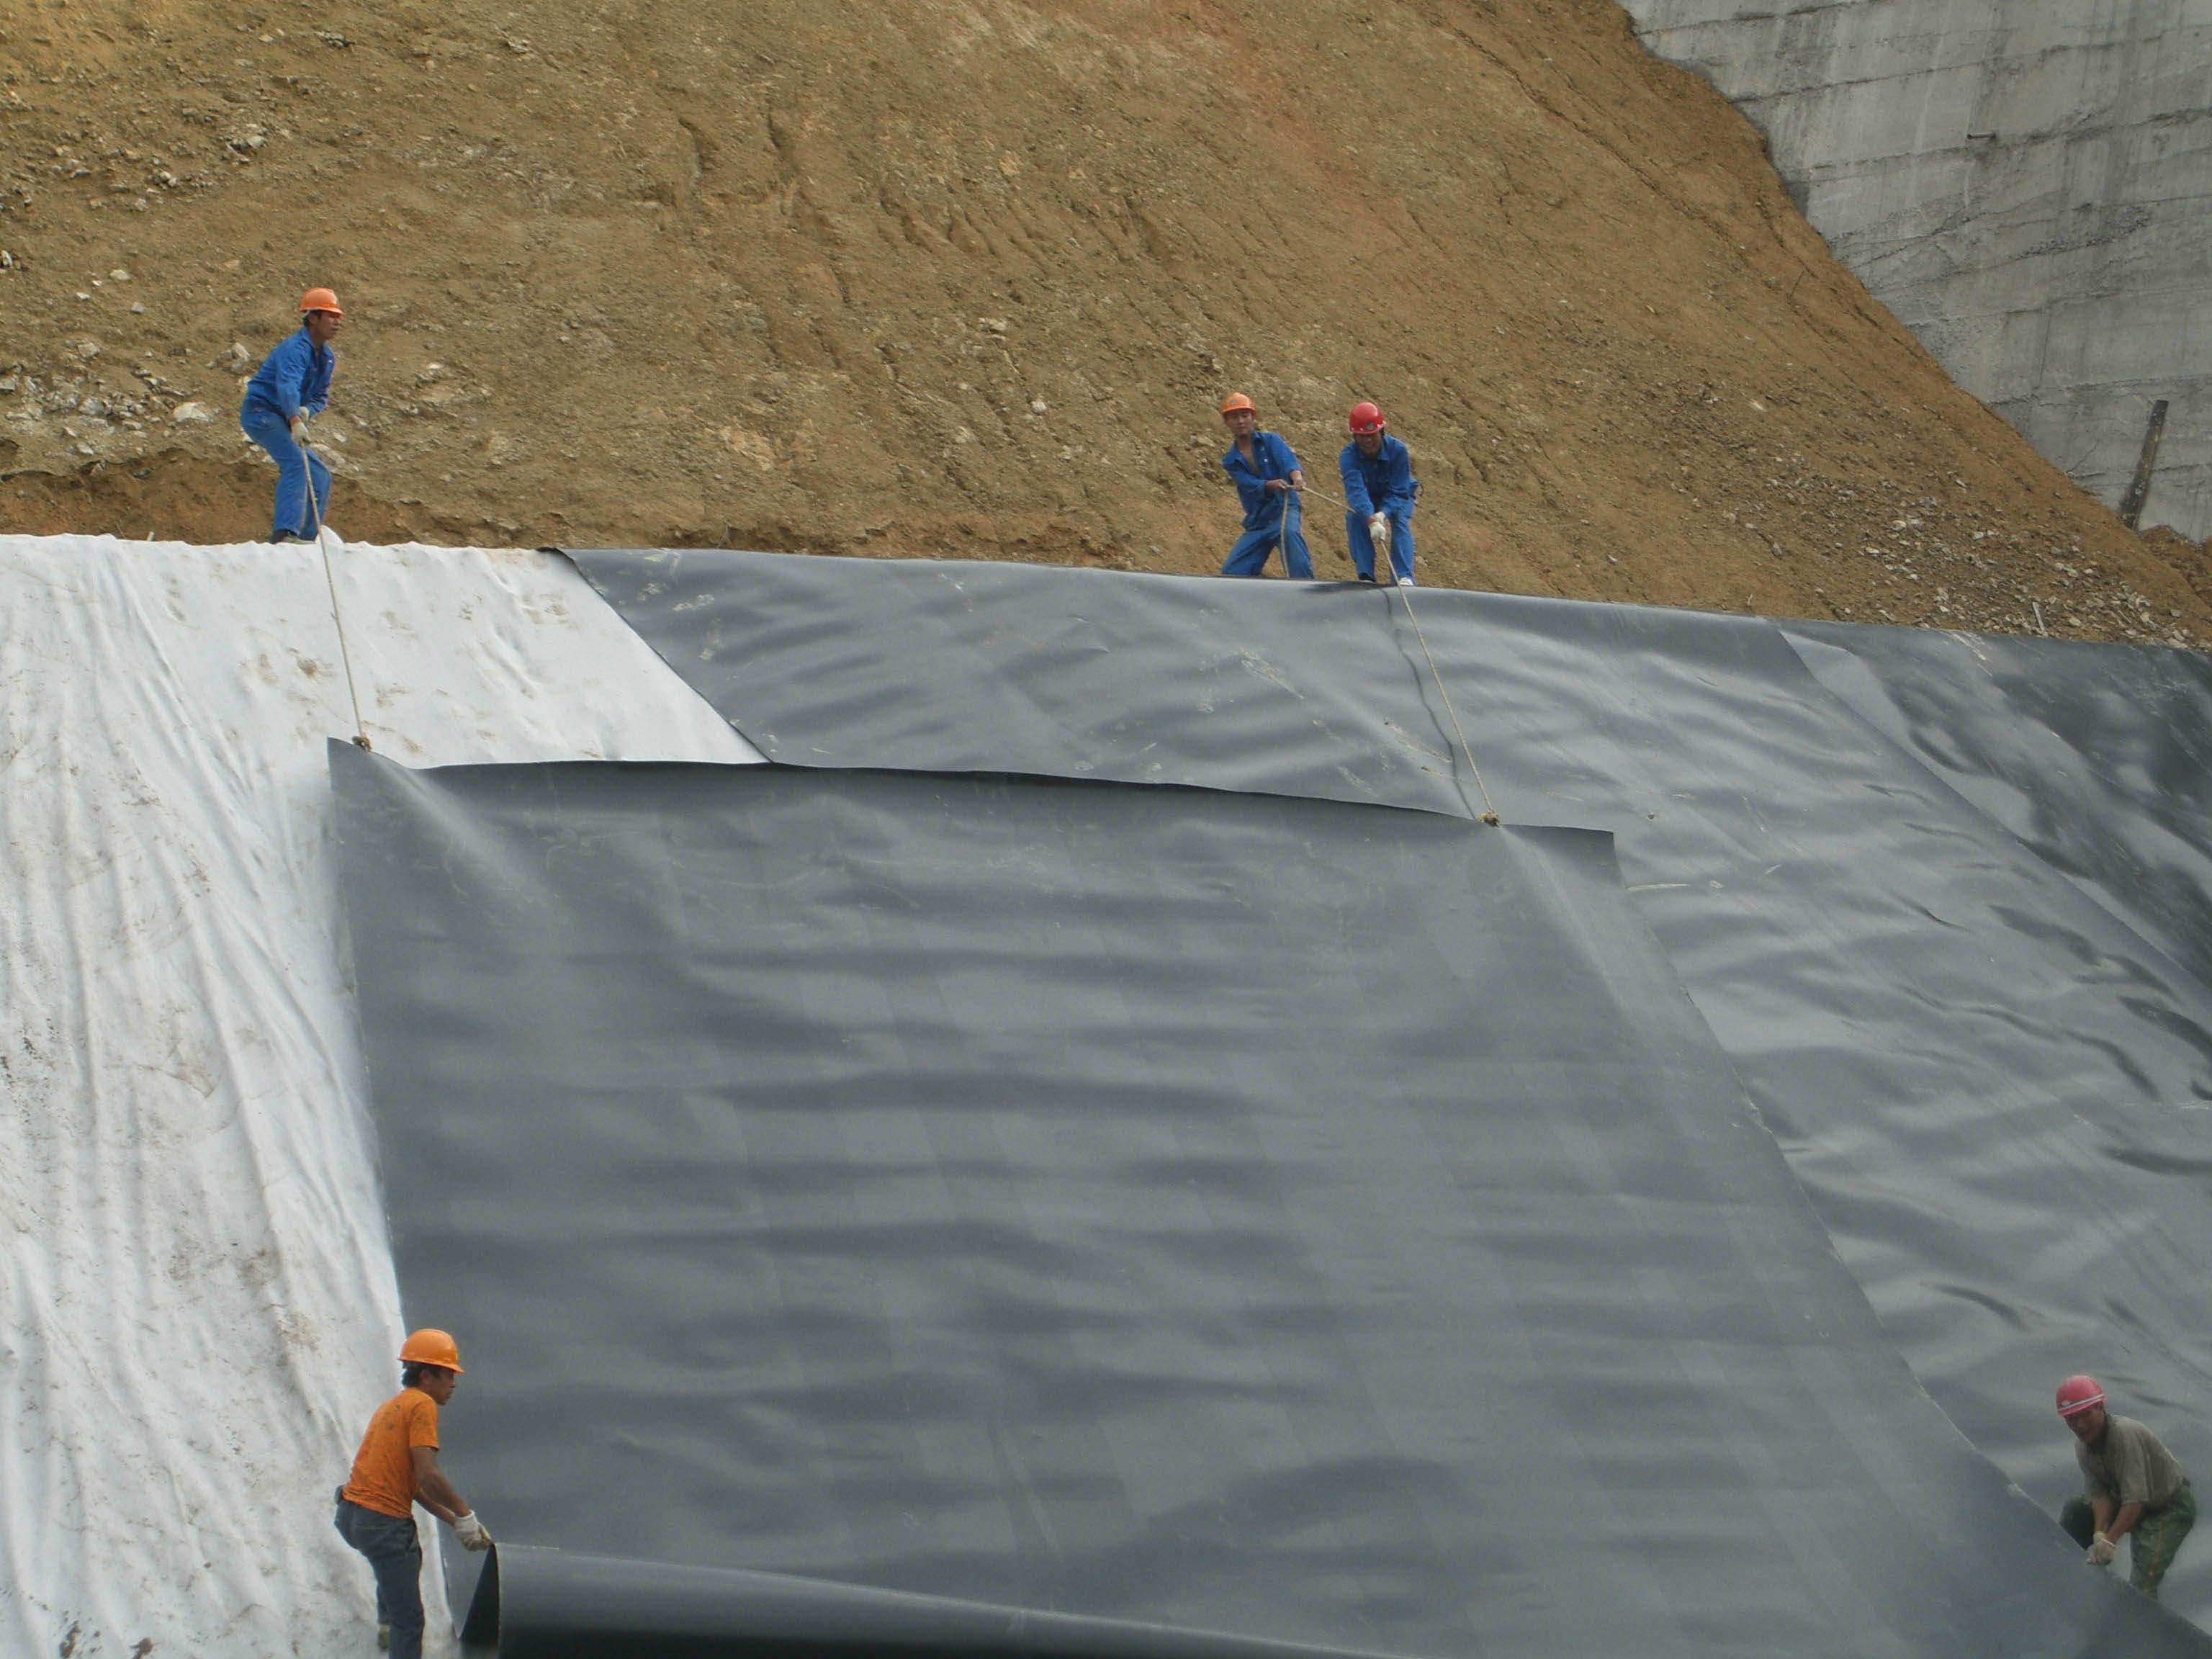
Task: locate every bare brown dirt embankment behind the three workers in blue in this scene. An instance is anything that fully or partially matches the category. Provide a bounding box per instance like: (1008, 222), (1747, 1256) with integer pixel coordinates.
(0, 0), (2212, 642)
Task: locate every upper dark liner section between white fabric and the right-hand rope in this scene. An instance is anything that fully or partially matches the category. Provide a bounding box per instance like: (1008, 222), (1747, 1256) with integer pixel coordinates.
(569, 551), (1473, 817)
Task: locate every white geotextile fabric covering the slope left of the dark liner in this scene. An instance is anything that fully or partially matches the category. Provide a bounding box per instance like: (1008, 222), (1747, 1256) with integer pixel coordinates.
(0, 535), (759, 1659)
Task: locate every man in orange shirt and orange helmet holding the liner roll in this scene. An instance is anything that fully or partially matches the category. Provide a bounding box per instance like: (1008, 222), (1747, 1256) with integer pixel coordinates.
(338, 1331), (491, 1659)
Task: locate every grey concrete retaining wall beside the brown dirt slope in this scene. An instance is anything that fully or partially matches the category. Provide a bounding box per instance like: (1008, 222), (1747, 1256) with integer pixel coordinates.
(1624, 0), (2212, 540)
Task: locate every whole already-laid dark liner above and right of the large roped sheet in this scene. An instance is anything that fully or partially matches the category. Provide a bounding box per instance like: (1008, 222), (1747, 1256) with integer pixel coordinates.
(577, 551), (2212, 1619)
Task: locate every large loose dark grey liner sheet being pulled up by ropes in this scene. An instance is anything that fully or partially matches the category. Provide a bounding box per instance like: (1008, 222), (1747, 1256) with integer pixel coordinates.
(332, 743), (2206, 1659)
